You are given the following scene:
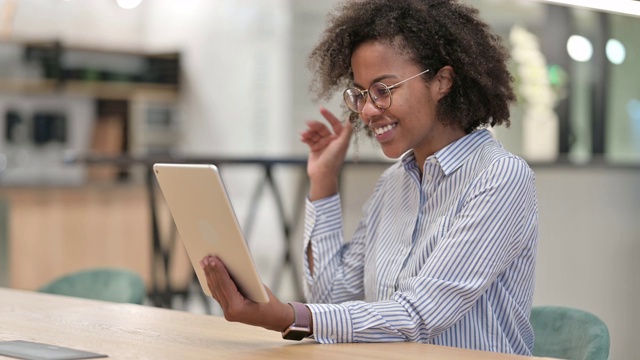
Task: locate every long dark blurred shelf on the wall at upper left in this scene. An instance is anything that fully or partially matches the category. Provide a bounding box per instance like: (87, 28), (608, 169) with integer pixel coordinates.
(0, 41), (180, 95)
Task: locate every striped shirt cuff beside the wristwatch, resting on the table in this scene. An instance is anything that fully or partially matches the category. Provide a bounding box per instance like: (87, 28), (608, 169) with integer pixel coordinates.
(305, 304), (353, 344)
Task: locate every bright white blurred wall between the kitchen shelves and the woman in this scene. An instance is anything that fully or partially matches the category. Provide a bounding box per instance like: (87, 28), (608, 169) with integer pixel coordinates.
(145, 0), (291, 155)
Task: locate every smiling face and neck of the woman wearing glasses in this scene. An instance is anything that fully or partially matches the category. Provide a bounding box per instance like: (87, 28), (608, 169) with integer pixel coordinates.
(351, 41), (465, 168)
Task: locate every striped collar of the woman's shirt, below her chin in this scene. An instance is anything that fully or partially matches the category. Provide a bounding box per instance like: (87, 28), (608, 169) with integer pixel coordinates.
(402, 129), (494, 176)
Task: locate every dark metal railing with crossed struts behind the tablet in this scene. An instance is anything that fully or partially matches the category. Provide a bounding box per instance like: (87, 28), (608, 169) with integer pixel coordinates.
(78, 155), (391, 311)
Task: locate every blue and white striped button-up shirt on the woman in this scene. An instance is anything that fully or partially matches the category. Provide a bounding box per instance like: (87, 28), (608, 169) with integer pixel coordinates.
(304, 130), (538, 355)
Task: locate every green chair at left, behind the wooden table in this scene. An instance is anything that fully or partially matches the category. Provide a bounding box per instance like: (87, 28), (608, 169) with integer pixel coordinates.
(38, 268), (146, 304)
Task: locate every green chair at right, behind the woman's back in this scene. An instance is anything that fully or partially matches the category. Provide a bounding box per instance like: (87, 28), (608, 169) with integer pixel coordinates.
(531, 306), (609, 360)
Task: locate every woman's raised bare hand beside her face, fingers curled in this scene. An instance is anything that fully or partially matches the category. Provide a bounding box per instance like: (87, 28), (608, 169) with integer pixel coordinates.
(300, 107), (353, 201)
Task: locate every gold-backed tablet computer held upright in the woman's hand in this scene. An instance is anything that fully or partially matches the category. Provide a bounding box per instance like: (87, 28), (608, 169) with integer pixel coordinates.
(153, 164), (269, 303)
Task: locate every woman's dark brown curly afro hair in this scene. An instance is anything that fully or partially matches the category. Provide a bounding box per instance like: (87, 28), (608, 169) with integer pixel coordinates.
(309, 0), (516, 133)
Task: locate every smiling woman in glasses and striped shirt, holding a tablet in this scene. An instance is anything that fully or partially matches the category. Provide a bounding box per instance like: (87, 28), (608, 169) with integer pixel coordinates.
(201, 0), (538, 355)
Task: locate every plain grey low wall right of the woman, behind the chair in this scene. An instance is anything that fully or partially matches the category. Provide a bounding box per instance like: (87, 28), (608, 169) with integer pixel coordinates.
(534, 167), (640, 359)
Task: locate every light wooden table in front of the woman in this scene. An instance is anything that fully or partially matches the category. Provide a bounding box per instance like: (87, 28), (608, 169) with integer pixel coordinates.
(0, 288), (556, 360)
